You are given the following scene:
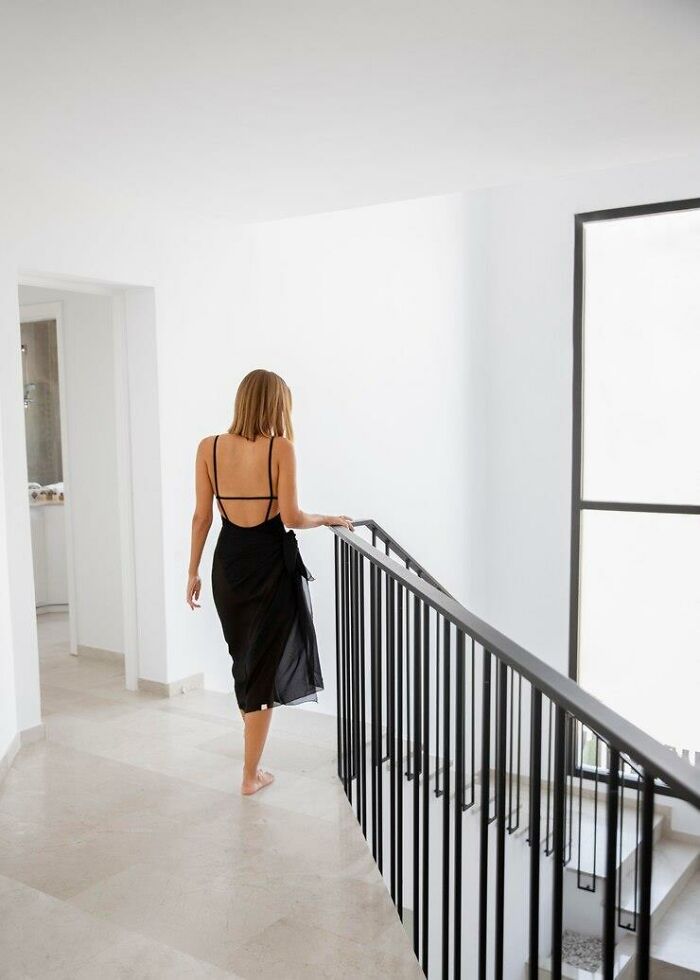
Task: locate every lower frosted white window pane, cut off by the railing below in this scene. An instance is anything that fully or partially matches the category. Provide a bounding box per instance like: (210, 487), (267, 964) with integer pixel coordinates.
(579, 511), (700, 752)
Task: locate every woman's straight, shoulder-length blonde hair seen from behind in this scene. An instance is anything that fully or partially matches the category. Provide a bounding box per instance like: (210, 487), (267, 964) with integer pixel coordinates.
(228, 368), (294, 441)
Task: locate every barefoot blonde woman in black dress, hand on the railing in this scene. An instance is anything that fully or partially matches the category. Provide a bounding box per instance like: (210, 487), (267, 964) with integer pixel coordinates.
(186, 370), (352, 796)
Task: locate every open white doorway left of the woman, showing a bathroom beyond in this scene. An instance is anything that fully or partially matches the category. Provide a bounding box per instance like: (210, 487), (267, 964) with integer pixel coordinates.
(18, 278), (148, 690)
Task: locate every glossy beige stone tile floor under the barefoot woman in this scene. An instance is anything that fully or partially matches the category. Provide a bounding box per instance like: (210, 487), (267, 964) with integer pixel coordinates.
(0, 613), (422, 980)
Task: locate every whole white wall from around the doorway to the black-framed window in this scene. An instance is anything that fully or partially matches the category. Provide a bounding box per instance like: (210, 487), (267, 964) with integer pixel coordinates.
(0, 140), (700, 764)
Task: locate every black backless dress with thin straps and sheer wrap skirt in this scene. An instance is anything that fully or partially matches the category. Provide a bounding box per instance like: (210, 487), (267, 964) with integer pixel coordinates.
(212, 435), (323, 711)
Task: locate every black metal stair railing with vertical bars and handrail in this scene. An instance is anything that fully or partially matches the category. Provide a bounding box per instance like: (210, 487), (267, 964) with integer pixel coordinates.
(333, 520), (700, 980)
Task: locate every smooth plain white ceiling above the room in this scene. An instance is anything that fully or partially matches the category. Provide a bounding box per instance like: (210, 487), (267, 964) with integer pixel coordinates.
(0, 0), (700, 220)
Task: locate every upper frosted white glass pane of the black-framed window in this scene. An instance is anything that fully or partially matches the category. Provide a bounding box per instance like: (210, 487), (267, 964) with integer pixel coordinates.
(583, 210), (700, 504)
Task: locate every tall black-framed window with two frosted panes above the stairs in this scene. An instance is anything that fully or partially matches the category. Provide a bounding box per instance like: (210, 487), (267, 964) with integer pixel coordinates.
(570, 200), (700, 765)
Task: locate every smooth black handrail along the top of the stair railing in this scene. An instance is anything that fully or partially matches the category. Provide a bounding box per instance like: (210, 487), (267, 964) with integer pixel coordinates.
(331, 520), (700, 809)
